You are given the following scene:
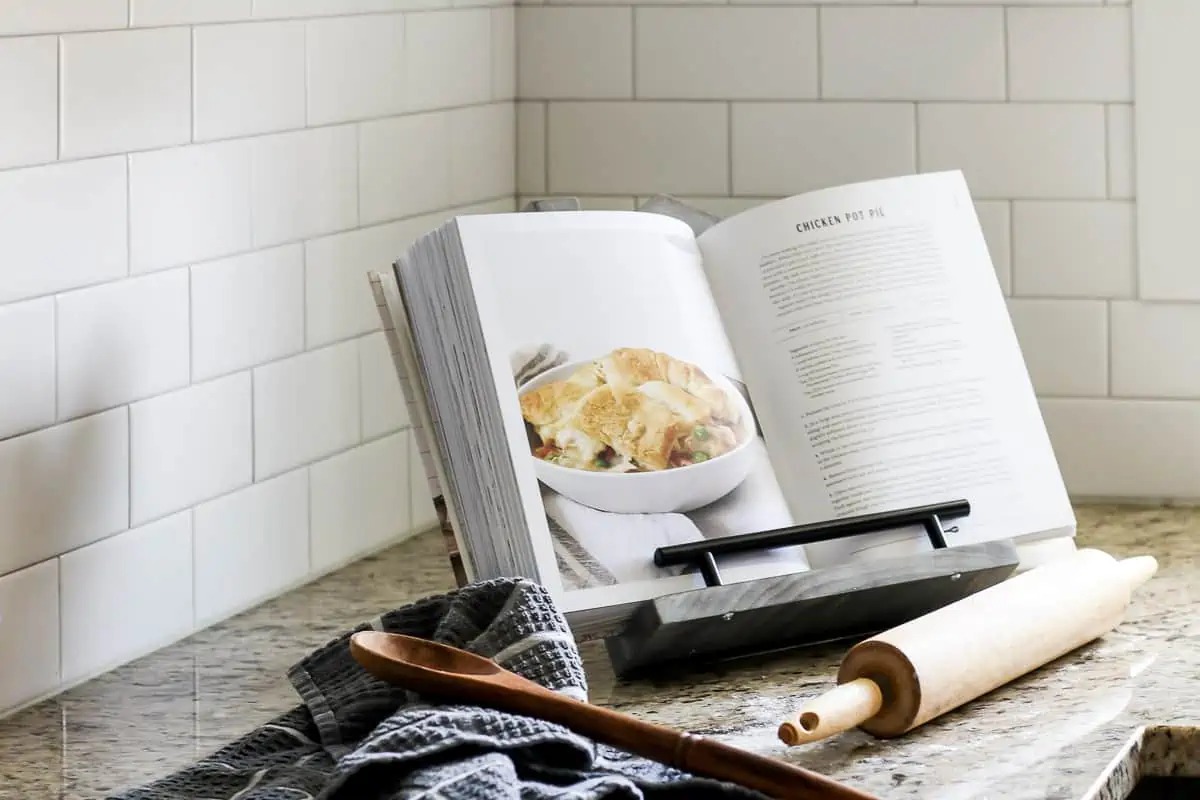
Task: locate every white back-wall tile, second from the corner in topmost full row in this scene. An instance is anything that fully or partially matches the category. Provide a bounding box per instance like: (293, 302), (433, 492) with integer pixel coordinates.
(638, 6), (818, 100)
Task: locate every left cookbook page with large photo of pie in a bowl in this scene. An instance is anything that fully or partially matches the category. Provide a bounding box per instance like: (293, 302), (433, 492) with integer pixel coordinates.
(458, 211), (806, 612)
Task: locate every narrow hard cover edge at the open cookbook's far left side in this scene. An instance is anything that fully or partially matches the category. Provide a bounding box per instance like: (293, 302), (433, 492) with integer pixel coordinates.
(367, 272), (469, 587)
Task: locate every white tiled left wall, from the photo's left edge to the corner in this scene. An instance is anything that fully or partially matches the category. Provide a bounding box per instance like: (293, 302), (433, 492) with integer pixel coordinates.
(0, 0), (514, 711)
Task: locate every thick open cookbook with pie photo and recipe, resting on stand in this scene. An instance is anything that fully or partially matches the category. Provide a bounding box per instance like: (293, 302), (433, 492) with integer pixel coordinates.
(371, 172), (1075, 638)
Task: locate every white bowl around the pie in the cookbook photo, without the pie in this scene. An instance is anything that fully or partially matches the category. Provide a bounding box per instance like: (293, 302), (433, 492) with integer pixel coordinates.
(518, 361), (755, 513)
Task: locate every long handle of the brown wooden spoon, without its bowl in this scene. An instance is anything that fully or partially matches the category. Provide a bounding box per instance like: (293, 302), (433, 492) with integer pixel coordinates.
(509, 686), (878, 800)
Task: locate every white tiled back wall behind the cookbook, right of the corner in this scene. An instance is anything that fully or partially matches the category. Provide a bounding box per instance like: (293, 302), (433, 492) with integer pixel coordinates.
(517, 0), (1200, 499)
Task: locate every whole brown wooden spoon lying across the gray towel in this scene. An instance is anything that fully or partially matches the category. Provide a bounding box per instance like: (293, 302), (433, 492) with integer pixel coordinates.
(350, 631), (877, 800)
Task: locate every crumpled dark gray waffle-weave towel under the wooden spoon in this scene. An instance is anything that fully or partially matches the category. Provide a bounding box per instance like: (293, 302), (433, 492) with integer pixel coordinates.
(114, 579), (761, 800)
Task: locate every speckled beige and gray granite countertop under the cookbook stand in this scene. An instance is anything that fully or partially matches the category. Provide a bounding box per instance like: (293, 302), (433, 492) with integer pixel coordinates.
(0, 507), (1200, 800)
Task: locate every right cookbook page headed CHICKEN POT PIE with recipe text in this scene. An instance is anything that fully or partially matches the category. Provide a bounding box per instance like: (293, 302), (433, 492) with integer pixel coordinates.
(698, 172), (1074, 566)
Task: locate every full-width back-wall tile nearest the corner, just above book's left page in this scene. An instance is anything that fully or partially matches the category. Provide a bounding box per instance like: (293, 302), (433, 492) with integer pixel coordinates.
(546, 102), (730, 194)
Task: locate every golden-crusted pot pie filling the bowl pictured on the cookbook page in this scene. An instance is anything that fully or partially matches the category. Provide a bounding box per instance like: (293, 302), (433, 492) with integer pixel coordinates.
(521, 348), (743, 473)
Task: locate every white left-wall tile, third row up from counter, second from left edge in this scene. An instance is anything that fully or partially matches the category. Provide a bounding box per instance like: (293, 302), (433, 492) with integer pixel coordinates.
(58, 270), (188, 419)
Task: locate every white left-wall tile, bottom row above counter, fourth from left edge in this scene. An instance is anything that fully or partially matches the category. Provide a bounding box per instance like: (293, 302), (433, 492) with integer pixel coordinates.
(308, 432), (412, 572)
